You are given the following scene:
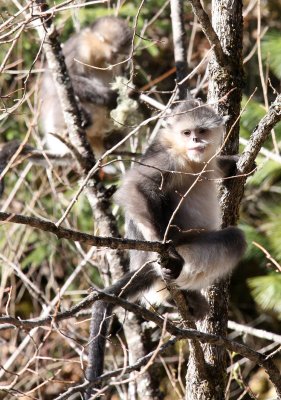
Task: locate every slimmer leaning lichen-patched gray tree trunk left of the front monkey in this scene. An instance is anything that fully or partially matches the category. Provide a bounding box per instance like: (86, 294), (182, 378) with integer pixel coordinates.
(36, 0), (158, 400)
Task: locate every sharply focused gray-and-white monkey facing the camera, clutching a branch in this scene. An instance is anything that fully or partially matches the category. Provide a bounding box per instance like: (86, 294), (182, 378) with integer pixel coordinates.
(85, 99), (246, 399)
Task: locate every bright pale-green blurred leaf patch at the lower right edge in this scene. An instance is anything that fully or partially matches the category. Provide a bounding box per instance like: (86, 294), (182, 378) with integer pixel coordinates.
(248, 272), (281, 317)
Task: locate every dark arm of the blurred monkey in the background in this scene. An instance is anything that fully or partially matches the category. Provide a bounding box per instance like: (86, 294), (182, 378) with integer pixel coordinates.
(71, 75), (117, 109)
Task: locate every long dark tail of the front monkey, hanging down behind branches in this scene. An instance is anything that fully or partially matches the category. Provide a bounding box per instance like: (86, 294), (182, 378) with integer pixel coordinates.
(84, 264), (159, 400)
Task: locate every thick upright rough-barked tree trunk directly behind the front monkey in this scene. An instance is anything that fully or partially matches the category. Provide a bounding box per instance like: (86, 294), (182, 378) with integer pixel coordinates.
(186, 0), (244, 400)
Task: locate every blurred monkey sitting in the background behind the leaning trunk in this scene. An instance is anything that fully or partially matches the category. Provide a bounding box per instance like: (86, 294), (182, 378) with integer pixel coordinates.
(40, 17), (133, 155)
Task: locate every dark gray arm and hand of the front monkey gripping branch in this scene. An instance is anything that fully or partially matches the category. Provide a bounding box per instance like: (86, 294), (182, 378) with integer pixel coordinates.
(115, 152), (184, 279)
